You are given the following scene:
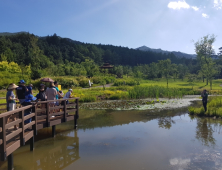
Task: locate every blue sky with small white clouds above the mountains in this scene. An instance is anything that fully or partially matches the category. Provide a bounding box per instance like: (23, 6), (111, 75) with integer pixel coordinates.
(0, 0), (222, 54)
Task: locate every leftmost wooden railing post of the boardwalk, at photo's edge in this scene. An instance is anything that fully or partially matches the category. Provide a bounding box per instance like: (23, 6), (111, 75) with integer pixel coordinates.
(0, 117), (6, 161)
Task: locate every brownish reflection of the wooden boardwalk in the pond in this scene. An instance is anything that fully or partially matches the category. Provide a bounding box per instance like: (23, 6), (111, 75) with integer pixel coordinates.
(0, 131), (80, 170)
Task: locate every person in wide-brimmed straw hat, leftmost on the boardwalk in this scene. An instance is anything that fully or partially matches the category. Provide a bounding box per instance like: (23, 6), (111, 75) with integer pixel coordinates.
(6, 83), (18, 129)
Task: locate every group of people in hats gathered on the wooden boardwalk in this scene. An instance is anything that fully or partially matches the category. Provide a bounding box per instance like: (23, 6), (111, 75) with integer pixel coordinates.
(6, 80), (72, 128)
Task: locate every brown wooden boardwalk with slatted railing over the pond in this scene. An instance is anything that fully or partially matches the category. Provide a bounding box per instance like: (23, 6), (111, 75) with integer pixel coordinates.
(0, 98), (79, 170)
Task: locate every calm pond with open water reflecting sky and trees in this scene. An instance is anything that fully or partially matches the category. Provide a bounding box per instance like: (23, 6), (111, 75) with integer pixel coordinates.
(0, 108), (222, 170)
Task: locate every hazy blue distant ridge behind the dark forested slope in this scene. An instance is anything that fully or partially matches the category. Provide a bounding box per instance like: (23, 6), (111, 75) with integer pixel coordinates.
(136, 46), (196, 58)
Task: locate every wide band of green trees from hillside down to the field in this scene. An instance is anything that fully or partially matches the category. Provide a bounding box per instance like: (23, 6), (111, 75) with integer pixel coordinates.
(0, 33), (222, 89)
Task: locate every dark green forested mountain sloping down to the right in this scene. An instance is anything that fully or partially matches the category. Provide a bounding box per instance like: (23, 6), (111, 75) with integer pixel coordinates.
(0, 33), (192, 68)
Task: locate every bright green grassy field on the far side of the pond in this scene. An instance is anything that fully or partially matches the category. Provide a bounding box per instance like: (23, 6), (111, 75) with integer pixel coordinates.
(0, 77), (222, 103)
